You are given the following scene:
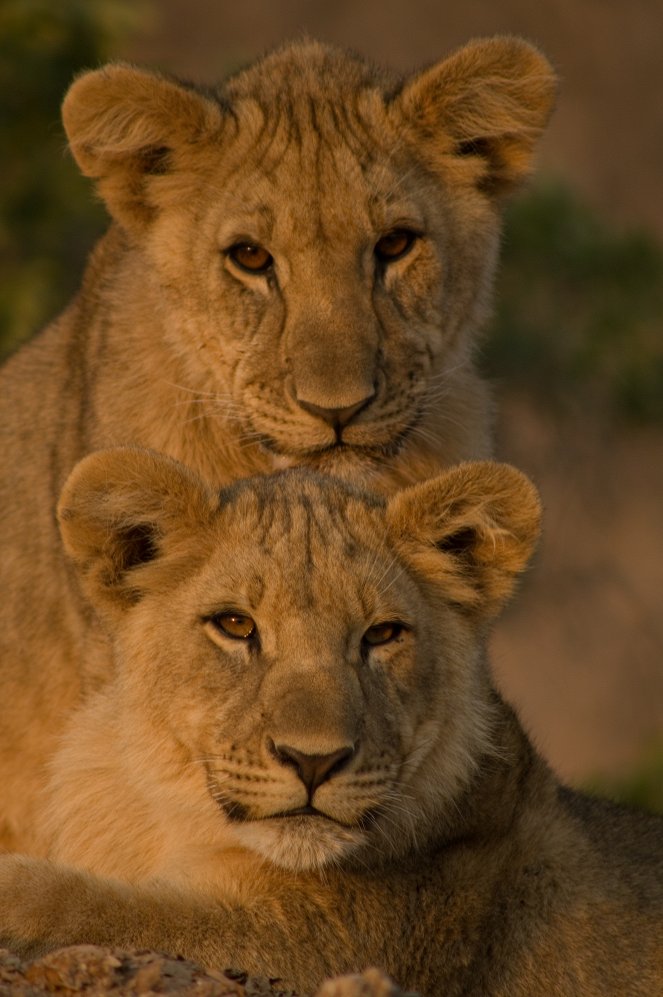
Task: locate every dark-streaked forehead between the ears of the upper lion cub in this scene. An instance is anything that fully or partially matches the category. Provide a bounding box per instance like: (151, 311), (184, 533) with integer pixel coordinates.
(215, 43), (404, 234)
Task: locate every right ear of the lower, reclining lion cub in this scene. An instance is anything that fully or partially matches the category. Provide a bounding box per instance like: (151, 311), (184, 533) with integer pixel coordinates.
(387, 461), (541, 618)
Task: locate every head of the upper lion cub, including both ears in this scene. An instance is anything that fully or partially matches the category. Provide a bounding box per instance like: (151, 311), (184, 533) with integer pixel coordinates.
(63, 39), (554, 468)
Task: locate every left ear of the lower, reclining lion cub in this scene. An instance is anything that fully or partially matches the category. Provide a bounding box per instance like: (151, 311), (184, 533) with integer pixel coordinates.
(58, 447), (218, 612)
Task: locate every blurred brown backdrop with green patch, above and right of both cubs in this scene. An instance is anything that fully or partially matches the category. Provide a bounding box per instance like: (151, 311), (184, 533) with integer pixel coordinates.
(0, 0), (663, 792)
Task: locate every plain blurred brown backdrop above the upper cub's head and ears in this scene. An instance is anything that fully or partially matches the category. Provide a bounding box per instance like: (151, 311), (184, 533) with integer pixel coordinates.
(128, 0), (663, 233)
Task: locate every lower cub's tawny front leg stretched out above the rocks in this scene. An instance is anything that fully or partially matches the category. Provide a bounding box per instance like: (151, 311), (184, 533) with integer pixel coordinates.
(0, 855), (358, 992)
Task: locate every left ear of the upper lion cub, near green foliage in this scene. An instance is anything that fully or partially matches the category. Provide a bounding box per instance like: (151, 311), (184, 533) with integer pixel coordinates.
(62, 63), (224, 229)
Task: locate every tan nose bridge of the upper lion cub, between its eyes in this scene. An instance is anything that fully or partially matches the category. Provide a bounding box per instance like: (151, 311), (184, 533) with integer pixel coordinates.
(286, 252), (379, 409)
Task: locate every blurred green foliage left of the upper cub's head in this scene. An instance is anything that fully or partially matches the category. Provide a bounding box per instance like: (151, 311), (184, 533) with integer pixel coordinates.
(0, 0), (150, 355)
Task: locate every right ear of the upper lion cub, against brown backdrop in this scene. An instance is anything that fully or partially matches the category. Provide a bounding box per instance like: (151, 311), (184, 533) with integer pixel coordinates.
(394, 37), (557, 195)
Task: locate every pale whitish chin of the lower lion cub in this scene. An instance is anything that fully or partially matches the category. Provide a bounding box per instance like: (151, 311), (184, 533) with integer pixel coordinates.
(234, 816), (366, 872)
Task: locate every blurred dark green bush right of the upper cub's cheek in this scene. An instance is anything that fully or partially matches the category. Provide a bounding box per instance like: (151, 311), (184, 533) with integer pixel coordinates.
(483, 184), (663, 422)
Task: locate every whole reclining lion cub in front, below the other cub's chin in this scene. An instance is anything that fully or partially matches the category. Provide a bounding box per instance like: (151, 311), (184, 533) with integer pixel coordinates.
(0, 448), (663, 997)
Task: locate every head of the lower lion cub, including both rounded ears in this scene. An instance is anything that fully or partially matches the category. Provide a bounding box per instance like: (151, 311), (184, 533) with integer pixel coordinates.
(59, 448), (539, 869)
